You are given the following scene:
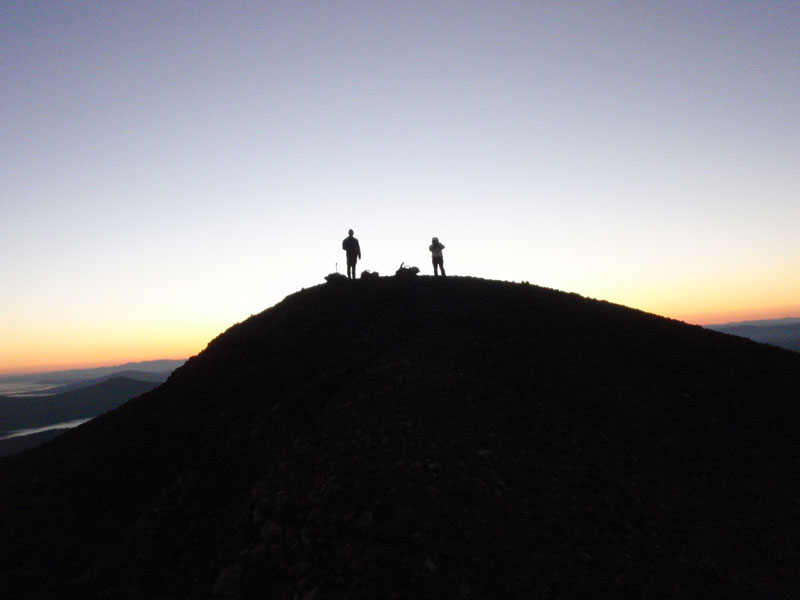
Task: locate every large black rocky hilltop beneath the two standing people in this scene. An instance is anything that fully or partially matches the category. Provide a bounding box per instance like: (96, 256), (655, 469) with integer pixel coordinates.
(0, 277), (800, 600)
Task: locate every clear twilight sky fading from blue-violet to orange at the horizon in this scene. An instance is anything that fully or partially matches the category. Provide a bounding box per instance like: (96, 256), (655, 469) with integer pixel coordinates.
(0, 0), (800, 373)
